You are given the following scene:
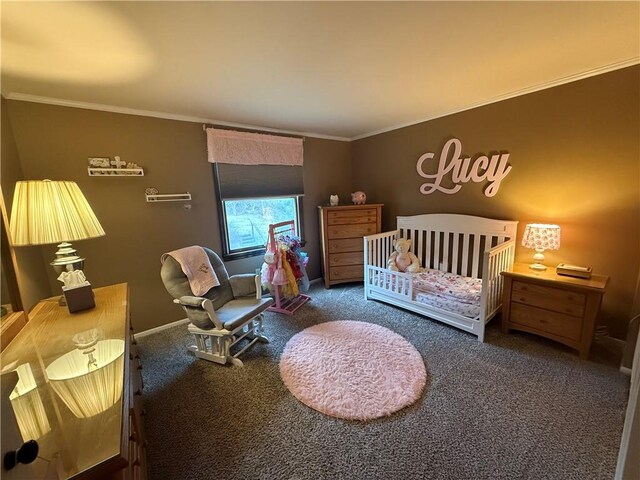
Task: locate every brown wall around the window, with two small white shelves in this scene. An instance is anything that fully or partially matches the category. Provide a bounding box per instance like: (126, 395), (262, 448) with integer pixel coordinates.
(7, 101), (351, 331)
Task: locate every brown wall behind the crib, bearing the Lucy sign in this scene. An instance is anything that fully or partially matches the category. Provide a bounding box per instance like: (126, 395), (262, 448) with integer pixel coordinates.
(352, 66), (640, 338)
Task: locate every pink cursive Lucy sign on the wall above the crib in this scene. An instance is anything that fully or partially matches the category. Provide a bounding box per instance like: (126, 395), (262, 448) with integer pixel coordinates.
(416, 138), (511, 197)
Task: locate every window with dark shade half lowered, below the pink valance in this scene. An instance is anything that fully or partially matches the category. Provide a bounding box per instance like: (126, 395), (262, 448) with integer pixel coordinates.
(213, 163), (303, 260)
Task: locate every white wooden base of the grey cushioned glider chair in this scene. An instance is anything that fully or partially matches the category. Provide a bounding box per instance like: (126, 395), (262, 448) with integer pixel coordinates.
(189, 314), (269, 367)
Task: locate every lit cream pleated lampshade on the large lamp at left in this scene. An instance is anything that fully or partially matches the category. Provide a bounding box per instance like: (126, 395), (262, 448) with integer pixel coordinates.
(10, 180), (105, 246)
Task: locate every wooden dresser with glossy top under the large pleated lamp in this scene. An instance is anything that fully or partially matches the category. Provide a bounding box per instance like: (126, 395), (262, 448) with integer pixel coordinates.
(0, 283), (146, 480)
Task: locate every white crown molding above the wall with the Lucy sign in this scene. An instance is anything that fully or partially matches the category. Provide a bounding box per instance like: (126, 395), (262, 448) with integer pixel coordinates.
(349, 57), (640, 142)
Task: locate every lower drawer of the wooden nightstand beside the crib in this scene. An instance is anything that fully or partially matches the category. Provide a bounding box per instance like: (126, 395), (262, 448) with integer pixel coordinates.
(510, 303), (582, 341)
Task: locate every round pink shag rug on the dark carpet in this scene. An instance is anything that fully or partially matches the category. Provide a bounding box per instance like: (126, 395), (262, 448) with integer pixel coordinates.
(280, 320), (427, 420)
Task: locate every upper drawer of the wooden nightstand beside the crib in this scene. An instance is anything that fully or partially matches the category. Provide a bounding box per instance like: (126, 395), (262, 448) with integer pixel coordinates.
(511, 281), (586, 317)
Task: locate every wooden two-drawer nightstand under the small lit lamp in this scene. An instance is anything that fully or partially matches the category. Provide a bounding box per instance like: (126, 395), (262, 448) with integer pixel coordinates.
(502, 263), (609, 360)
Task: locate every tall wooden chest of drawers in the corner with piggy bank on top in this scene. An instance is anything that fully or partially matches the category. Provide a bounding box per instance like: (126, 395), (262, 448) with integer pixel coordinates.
(318, 203), (382, 288)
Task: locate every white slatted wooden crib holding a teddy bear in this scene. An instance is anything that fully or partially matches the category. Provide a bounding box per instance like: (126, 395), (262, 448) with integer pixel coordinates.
(364, 214), (518, 342)
